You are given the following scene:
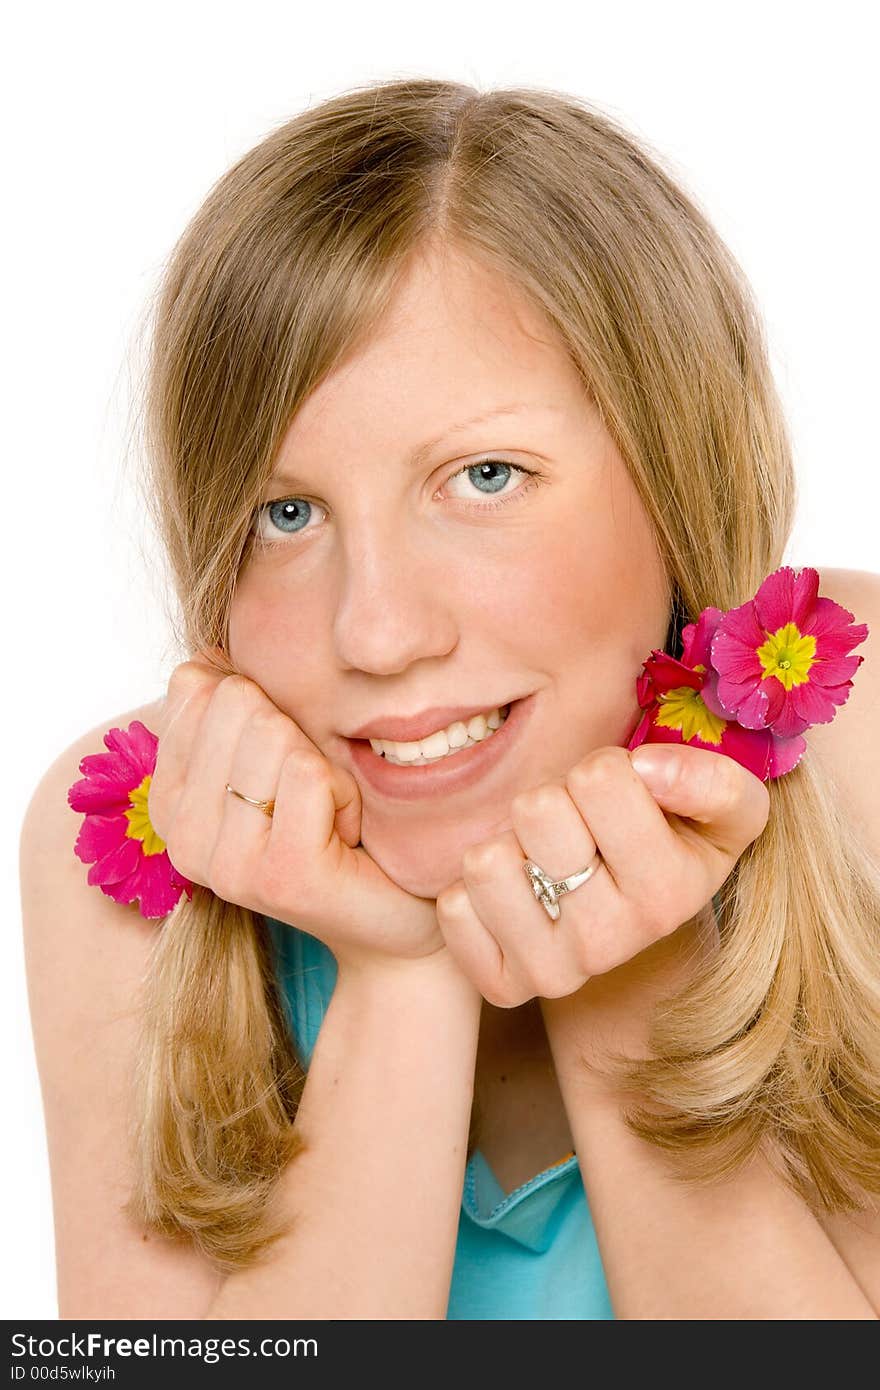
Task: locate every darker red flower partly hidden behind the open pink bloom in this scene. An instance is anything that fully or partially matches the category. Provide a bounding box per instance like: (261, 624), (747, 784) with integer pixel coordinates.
(626, 607), (806, 781)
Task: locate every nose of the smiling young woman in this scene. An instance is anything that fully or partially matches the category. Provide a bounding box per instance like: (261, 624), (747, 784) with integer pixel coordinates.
(334, 521), (459, 676)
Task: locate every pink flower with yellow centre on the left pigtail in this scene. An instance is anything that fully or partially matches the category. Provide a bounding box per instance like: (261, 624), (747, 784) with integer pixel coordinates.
(67, 719), (192, 917)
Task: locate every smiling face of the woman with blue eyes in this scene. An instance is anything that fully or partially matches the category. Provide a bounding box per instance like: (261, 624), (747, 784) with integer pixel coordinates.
(229, 240), (670, 897)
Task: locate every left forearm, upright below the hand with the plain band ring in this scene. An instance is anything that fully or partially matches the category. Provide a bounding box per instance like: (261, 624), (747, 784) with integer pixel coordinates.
(207, 952), (481, 1319)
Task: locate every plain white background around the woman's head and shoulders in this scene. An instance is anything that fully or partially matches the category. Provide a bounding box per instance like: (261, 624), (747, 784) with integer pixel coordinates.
(0, 0), (880, 1318)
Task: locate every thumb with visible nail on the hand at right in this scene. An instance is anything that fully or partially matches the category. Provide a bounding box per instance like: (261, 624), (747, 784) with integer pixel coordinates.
(630, 744), (770, 853)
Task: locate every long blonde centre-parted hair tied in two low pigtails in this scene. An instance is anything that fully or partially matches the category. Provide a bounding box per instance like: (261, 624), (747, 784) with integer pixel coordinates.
(128, 79), (880, 1270)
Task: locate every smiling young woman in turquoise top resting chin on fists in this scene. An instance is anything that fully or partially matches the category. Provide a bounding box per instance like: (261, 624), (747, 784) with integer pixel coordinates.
(22, 79), (880, 1319)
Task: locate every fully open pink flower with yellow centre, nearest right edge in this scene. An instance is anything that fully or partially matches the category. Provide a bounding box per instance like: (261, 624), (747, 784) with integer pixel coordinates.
(710, 564), (867, 738)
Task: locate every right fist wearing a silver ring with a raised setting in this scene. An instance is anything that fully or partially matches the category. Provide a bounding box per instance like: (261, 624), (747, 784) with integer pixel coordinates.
(437, 744), (770, 1008)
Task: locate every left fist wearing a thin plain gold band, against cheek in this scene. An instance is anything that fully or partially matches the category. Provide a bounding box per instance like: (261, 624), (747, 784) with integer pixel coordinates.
(149, 656), (446, 966)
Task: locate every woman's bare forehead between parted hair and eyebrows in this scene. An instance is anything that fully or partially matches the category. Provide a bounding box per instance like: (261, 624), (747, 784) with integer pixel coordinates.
(281, 249), (587, 461)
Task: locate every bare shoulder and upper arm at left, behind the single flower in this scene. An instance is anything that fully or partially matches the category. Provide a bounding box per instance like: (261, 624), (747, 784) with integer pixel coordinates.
(19, 701), (220, 1319)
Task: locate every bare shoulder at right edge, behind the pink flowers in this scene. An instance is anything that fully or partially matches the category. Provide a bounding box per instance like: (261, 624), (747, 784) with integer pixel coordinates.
(805, 570), (880, 862)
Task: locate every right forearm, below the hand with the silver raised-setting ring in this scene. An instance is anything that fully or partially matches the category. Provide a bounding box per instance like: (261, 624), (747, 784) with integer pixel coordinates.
(542, 987), (877, 1321)
